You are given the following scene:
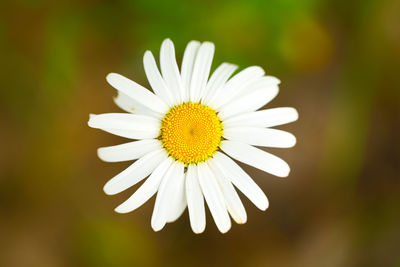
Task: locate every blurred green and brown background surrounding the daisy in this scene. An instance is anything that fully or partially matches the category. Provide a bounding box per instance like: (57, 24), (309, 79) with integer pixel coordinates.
(0, 0), (400, 267)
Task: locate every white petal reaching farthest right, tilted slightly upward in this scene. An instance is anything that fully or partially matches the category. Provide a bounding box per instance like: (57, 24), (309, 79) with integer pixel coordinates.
(224, 107), (299, 129)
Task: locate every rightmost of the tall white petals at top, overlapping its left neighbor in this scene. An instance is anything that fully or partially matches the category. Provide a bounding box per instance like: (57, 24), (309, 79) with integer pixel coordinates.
(190, 42), (214, 102)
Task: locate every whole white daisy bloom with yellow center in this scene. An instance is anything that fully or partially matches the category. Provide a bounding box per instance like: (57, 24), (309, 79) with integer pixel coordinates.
(89, 39), (298, 233)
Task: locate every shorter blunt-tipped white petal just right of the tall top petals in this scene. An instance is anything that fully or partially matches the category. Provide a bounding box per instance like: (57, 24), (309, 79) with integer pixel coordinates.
(201, 63), (238, 105)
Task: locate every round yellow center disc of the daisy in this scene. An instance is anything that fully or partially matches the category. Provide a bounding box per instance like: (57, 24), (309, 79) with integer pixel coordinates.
(160, 102), (222, 164)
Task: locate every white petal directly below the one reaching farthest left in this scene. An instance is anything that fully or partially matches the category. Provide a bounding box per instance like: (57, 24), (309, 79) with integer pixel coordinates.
(97, 139), (162, 162)
